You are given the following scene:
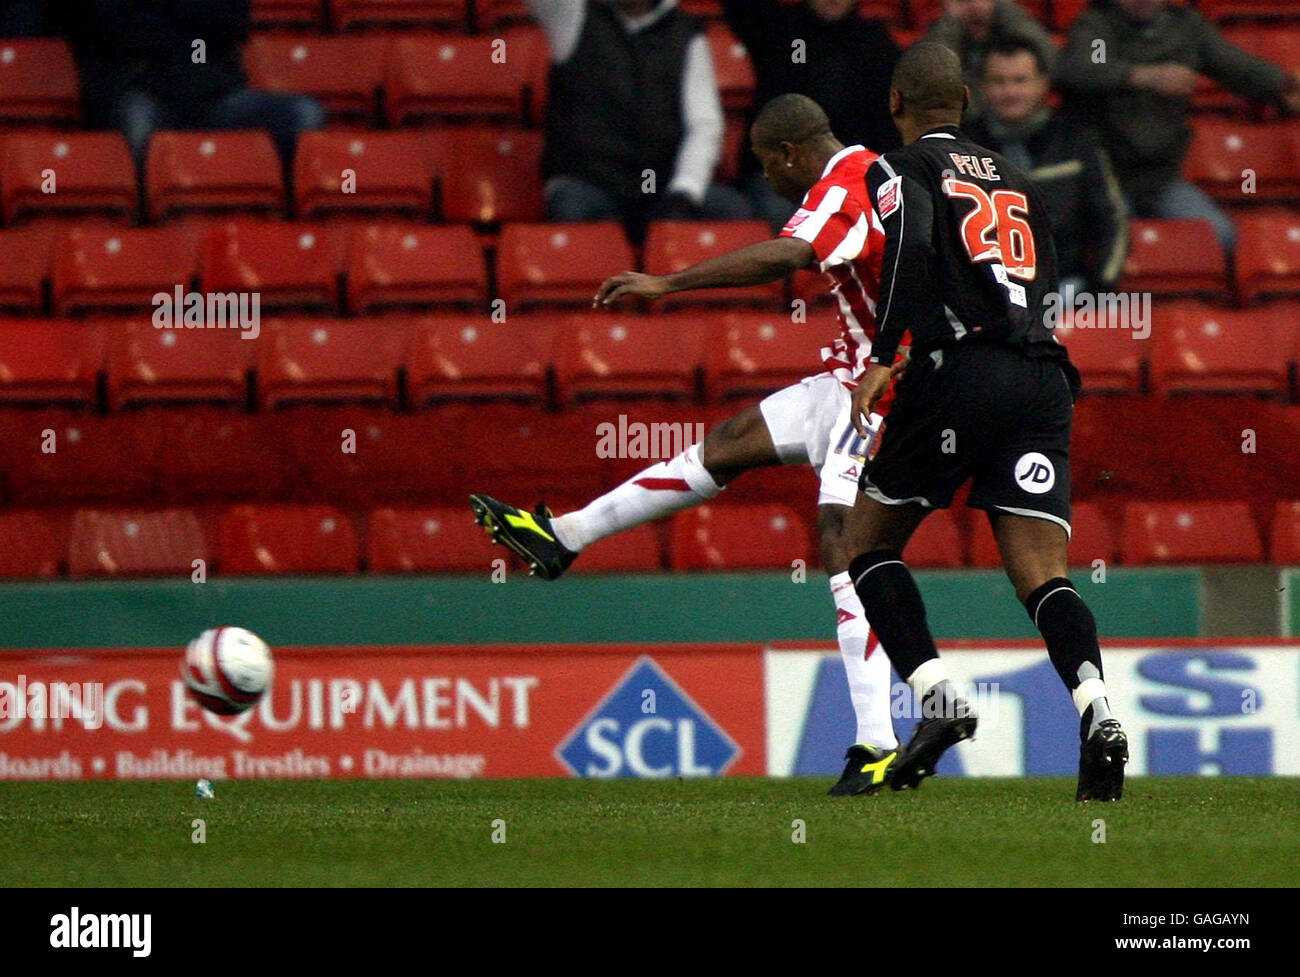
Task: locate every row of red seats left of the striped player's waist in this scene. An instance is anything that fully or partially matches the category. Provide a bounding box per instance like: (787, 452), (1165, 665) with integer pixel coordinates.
(0, 313), (820, 409)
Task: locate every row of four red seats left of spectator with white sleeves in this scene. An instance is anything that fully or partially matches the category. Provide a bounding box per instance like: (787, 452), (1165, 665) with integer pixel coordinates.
(0, 126), (543, 223)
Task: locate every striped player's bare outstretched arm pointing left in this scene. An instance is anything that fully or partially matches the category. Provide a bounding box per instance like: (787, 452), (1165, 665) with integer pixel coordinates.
(593, 238), (815, 305)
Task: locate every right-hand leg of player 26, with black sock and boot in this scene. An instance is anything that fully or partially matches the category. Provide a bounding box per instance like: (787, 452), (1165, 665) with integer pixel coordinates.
(993, 513), (1128, 800)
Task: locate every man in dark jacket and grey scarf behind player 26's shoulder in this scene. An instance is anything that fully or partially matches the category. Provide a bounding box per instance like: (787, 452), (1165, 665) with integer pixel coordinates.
(966, 40), (1128, 294)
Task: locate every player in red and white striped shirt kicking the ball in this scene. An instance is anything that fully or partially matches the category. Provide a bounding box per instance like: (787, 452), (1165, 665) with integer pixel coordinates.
(471, 95), (898, 794)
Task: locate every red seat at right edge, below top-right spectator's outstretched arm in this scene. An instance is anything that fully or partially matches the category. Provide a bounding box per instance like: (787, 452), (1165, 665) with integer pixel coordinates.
(1184, 118), (1300, 203)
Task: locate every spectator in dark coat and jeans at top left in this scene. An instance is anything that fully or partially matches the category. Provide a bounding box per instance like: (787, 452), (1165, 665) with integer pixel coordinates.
(49, 0), (325, 169)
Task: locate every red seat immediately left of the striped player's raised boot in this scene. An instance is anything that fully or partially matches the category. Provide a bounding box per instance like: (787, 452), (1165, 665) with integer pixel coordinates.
(365, 505), (499, 577)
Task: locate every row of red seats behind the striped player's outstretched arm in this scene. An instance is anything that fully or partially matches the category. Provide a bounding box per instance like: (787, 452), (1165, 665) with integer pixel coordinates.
(0, 218), (784, 316)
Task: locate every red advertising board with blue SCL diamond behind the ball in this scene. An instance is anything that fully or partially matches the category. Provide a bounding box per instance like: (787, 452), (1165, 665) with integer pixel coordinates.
(0, 644), (766, 780)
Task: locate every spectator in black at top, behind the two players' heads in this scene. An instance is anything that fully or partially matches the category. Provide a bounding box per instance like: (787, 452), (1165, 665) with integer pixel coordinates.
(723, 0), (901, 230)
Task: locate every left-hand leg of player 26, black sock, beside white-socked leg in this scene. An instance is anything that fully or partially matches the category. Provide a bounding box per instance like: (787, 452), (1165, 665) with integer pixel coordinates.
(849, 495), (979, 790)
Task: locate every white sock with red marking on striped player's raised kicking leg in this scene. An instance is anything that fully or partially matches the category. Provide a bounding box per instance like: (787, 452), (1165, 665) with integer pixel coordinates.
(551, 444), (722, 553)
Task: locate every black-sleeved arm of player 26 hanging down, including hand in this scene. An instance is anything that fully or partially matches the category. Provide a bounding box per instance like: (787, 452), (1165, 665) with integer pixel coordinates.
(852, 160), (939, 435)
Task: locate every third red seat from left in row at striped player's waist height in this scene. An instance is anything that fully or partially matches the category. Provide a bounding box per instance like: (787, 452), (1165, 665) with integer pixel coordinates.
(257, 320), (408, 407)
